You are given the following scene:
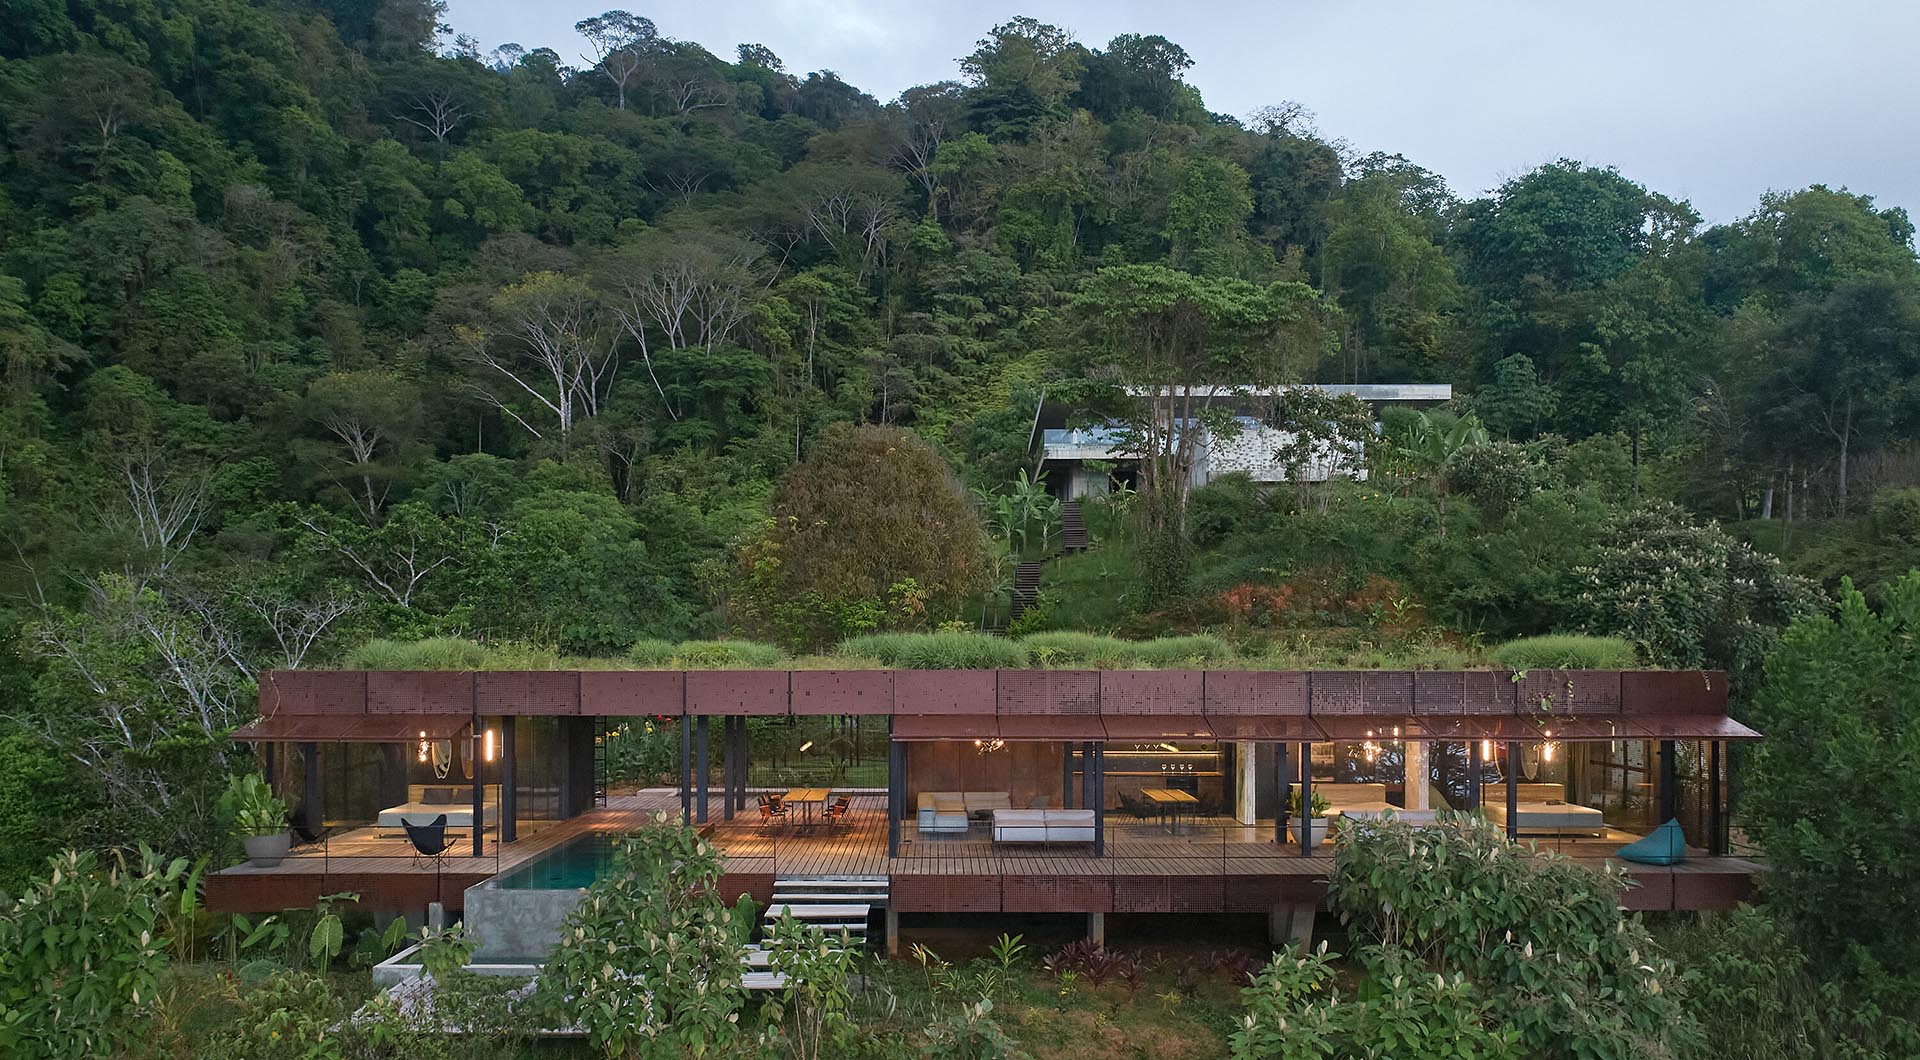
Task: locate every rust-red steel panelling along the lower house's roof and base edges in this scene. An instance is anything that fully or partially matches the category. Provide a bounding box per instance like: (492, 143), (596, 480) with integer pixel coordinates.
(209, 670), (1759, 912)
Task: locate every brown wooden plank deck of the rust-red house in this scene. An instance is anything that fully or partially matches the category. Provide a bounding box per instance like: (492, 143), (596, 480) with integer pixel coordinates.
(207, 789), (1761, 912)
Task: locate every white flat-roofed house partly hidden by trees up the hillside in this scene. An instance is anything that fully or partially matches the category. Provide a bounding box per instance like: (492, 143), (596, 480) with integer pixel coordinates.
(1035, 382), (1453, 501)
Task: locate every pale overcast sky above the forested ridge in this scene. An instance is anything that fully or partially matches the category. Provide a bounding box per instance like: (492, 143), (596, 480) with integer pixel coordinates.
(447, 0), (1920, 221)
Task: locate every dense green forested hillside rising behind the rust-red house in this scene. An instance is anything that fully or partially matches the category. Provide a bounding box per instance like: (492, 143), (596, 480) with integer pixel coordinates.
(0, 0), (1920, 864)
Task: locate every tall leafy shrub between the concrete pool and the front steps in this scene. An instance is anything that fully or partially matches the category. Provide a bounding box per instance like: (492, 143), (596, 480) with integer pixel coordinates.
(538, 814), (751, 1058)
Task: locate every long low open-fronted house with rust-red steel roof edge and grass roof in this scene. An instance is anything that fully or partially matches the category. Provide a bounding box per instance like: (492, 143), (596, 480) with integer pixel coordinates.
(207, 670), (1759, 939)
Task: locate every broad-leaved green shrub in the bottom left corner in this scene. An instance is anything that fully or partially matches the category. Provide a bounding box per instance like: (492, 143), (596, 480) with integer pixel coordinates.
(0, 847), (186, 1060)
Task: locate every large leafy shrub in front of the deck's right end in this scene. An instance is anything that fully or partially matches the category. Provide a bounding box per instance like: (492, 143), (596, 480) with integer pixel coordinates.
(1329, 814), (1697, 1060)
